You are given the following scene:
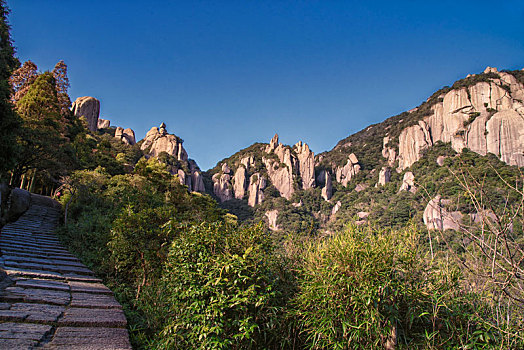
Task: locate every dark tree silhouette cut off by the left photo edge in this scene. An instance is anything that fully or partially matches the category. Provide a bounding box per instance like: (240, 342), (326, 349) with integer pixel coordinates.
(0, 0), (20, 180)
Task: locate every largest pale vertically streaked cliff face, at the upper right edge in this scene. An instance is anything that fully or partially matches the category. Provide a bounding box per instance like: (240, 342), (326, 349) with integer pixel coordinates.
(398, 67), (524, 170)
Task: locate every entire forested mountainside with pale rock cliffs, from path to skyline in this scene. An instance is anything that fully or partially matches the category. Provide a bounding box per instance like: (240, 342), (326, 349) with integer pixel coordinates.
(0, 0), (524, 349)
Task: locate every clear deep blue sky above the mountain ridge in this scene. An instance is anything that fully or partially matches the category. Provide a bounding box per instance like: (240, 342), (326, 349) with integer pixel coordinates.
(7, 0), (524, 169)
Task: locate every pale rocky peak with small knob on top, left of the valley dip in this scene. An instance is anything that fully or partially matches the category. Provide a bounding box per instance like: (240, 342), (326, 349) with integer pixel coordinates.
(139, 123), (205, 192)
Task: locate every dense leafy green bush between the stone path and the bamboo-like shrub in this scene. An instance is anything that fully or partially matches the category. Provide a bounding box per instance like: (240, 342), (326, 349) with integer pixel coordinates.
(145, 223), (283, 349)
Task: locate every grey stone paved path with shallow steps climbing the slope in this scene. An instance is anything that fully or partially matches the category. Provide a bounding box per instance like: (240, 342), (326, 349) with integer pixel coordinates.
(0, 195), (131, 349)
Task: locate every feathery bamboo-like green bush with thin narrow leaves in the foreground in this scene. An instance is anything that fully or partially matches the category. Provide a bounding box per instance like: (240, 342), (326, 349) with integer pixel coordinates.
(294, 227), (498, 349)
